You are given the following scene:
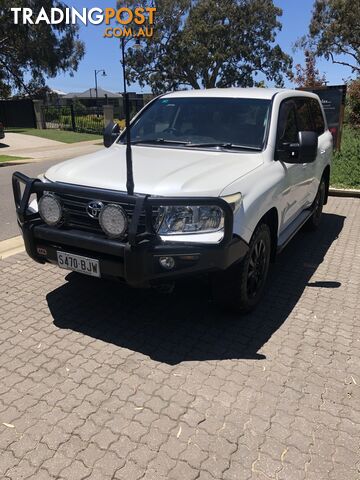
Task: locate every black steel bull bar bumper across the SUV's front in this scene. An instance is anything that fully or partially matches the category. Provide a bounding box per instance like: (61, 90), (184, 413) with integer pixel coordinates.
(13, 173), (248, 287)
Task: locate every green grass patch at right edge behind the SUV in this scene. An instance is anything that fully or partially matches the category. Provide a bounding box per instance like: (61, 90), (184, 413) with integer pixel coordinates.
(330, 125), (360, 189)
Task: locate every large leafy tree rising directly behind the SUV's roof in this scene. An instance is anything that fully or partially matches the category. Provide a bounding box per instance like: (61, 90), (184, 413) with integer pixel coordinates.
(126, 0), (292, 93)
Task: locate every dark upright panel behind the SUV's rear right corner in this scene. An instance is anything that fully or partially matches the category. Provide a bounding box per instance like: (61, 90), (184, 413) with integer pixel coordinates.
(299, 85), (346, 150)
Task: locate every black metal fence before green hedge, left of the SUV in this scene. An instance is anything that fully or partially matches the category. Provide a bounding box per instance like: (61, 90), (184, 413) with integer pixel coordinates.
(42, 105), (104, 135)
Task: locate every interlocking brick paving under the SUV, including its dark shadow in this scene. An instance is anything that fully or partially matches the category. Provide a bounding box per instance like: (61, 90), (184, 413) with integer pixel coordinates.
(0, 198), (360, 480)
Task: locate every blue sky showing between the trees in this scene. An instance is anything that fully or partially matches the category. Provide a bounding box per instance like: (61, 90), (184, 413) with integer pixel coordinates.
(48, 0), (351, 93)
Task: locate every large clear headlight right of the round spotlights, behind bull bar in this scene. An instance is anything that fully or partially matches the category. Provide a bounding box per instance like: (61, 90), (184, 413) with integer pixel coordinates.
(156, 205), (224, 235)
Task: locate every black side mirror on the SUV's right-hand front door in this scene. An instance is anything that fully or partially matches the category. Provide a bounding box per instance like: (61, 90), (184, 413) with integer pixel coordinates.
(275, 132), (318, 163)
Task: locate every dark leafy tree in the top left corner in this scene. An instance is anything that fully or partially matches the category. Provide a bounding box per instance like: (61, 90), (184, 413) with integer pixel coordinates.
(0, 0), (84, 98)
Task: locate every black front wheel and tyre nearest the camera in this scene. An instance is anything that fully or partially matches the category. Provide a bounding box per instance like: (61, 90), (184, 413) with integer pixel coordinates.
(212, 223), (271, 313)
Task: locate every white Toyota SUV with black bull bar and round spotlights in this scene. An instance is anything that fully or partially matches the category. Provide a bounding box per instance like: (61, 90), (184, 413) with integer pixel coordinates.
(13, 88), (332, 311)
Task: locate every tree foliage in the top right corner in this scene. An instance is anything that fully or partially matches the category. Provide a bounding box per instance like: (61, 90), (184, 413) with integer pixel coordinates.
(302, 0), (360, 73)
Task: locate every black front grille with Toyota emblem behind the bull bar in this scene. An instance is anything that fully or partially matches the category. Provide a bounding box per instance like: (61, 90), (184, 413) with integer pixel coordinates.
(57, 194), (158, 236)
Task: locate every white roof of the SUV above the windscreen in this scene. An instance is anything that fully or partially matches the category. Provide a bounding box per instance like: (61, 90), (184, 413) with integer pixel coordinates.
(165, 87), (311, 100)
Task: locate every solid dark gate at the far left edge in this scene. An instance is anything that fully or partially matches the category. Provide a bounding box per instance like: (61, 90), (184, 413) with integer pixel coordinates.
(0, 100), (36, 128)
